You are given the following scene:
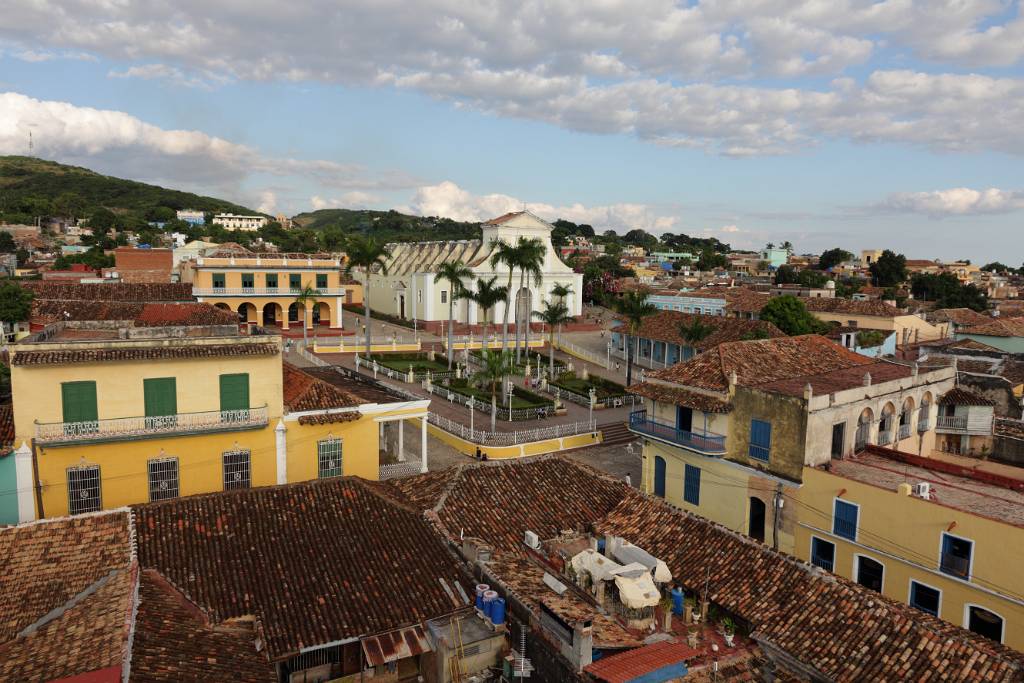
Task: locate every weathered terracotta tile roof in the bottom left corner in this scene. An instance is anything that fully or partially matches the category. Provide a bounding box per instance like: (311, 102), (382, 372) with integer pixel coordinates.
(0, 510), (136, 681)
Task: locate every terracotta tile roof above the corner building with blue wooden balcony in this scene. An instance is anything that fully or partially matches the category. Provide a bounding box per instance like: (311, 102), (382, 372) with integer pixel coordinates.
(647, 335), (877, 392)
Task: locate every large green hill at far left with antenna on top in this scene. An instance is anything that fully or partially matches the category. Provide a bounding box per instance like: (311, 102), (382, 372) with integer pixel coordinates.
(0, 157), (255, 224)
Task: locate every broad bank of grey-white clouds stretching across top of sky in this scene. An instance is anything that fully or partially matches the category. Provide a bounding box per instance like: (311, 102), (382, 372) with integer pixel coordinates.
(0, 0), (1024, 157)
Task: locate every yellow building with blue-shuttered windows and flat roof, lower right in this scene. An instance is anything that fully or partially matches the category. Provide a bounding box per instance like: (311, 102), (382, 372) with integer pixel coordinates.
(792, 446), (1024, 650)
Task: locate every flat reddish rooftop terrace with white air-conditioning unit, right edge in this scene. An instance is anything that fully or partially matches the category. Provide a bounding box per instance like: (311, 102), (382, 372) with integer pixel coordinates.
(829, 446), (1024, 527)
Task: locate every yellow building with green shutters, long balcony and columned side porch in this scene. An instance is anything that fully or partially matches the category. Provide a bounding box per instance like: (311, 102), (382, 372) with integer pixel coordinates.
(11, 315), (428, 521)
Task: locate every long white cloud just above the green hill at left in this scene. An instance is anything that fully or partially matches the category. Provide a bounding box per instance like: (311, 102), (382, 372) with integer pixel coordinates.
(0, 92), (416, 201)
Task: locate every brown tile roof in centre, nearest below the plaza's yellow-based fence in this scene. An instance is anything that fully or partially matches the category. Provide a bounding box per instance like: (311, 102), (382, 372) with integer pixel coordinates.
(392, 458), (622, 550)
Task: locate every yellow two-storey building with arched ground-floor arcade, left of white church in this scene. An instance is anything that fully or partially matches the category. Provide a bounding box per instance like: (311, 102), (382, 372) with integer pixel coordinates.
(188, 252), (362, 330)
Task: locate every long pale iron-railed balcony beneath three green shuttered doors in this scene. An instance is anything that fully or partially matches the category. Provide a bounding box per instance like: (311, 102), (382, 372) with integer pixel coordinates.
(36, 407), (268, 445)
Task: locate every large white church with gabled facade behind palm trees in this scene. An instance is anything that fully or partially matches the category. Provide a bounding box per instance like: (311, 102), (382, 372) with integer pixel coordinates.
(370, 211), (583, 329)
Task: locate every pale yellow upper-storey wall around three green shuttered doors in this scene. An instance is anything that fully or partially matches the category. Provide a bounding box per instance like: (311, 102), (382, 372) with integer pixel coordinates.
(11, 352), (282, 443)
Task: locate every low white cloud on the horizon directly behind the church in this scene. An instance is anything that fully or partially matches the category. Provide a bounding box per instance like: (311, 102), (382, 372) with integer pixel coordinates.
(397, 180), (677, 232)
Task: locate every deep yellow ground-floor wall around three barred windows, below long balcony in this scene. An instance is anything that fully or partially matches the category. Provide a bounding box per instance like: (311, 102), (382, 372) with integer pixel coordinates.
(36, 423), (278, 517)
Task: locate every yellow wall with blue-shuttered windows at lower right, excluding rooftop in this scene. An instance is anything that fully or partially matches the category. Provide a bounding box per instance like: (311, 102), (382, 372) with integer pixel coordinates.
(793, 468), (1024, 650)
